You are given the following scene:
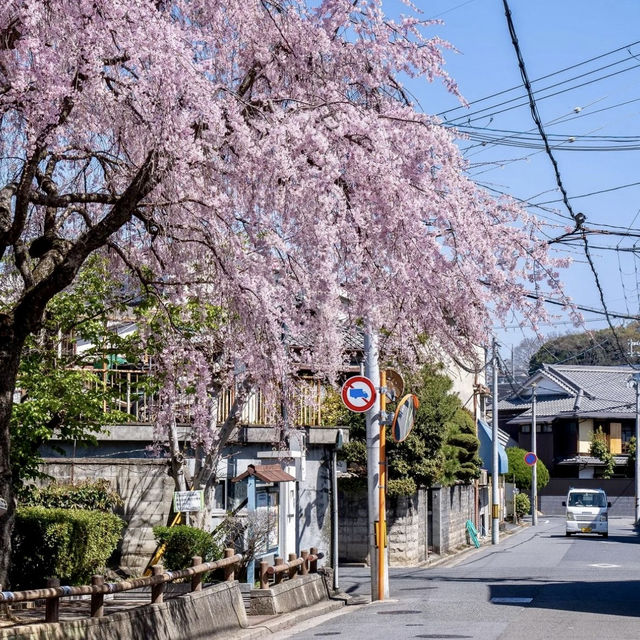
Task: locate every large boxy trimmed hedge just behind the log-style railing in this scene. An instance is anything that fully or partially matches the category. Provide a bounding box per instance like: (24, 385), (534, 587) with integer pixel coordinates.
(10, 507), (125, 589)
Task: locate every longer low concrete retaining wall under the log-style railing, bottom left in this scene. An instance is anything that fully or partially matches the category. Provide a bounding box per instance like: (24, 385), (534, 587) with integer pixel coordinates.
(0, 582), (248, 640)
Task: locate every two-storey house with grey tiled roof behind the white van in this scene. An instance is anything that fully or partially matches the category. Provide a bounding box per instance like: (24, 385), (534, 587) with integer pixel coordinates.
(498, 364), (636, 515)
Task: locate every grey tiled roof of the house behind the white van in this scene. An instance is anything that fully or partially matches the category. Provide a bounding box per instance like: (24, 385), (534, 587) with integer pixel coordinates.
(498, 364), (636, 424)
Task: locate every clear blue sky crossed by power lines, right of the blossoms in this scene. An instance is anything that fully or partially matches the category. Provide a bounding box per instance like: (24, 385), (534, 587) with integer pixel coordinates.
(386, 0), (640, 356)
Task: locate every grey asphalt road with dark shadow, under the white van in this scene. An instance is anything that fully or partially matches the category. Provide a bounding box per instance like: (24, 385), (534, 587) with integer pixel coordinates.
(274, 516), (640, 640)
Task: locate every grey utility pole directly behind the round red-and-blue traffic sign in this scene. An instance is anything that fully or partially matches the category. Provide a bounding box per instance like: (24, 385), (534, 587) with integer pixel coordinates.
(364, 327), (389, 600)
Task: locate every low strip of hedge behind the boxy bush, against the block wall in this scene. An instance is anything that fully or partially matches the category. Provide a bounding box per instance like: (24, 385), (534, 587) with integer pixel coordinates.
(20, 479), (122, 511)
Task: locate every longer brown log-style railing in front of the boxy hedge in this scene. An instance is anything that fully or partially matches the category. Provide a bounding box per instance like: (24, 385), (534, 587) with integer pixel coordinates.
(0, 549), (242, 622)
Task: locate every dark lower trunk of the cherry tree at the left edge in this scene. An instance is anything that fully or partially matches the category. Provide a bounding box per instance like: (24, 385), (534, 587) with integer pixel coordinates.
(0, 315), (24, 589)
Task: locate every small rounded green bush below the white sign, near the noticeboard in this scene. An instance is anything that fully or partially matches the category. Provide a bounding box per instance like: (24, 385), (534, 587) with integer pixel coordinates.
(153, 525), (222, 571)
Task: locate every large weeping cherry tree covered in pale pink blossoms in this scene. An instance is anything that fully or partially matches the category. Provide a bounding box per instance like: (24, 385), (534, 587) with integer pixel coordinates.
(0, 0), (558, 583)
